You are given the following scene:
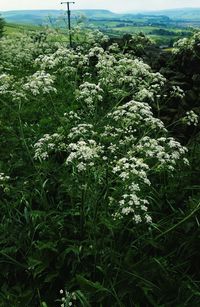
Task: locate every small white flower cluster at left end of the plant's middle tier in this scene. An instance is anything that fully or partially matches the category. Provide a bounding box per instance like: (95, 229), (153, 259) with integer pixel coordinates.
(34, 133), (66, 160)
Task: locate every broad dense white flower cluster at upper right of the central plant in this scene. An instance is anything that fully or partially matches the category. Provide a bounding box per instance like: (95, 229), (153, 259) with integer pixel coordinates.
(96, 52), (166, 102)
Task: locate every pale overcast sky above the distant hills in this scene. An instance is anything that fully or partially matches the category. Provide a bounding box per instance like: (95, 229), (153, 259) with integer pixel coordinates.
(0, 0), (200, 12)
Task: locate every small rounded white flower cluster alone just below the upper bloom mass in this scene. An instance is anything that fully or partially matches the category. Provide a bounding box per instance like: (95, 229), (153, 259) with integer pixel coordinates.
(76, 82), (103, 114)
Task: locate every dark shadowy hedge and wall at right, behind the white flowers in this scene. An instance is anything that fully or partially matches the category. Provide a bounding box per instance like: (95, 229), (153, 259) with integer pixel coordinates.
(104, 32), (200, 142)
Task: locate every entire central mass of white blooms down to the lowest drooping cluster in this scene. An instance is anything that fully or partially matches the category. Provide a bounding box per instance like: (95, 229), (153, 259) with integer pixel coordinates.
(25, 35), (187, 224)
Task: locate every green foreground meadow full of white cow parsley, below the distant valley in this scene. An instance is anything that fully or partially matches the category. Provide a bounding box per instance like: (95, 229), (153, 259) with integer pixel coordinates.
(0, 21), (200, 307)
